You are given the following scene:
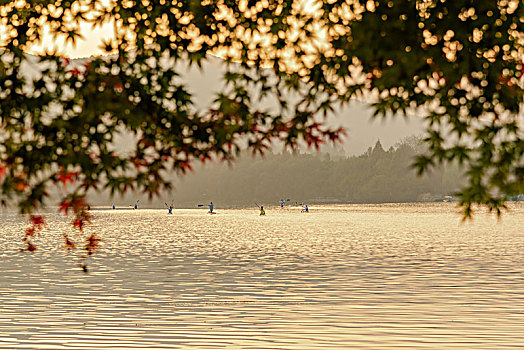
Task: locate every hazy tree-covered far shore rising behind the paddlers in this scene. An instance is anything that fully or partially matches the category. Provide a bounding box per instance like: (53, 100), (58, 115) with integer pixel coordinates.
(162, 137), (461, 207)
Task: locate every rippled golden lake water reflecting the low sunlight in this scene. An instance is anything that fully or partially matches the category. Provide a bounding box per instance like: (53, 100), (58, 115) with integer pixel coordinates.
(0, 203), (524, 349)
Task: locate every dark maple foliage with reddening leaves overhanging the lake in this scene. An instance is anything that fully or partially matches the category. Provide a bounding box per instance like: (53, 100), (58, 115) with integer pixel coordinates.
(0, 0), (524, 246)
